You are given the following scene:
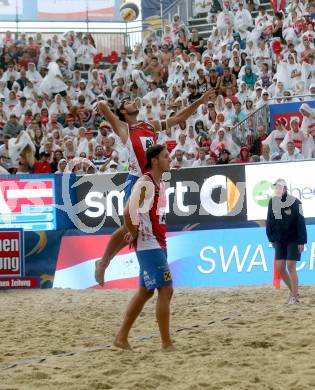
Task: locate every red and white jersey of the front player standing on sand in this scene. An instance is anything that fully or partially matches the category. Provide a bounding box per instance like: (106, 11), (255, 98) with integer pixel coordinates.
(135, 173), (166, 251)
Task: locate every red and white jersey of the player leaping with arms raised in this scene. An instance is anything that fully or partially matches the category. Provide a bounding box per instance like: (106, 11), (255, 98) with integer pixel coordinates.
(126, 122), (157, 177)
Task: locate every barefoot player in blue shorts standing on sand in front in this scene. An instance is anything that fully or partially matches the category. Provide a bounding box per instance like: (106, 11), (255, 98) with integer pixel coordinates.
(114, 145), (174, 351)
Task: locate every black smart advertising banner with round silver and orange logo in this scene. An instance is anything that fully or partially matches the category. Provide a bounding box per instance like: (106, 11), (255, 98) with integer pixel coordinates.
(74, 165), (246, 232)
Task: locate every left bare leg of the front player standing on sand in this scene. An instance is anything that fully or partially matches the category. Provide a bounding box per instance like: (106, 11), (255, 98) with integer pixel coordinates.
(114, 286), (154, 349)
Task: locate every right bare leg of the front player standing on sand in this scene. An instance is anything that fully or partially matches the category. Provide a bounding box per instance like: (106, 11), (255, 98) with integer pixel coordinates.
(156, 285), (174, 351)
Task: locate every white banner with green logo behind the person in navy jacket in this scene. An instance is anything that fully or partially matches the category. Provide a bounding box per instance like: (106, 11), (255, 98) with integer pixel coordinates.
(245, 161), (315, 221)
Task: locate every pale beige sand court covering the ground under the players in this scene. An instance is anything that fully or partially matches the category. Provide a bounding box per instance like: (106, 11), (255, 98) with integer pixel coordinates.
(0, 287), (315, 390)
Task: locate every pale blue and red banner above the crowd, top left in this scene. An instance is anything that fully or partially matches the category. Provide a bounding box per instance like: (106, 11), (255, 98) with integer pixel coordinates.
(0, 0), (122, 22)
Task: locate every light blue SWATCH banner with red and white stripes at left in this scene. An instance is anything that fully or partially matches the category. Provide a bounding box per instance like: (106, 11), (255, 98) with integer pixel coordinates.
(53, 226), (315, 289)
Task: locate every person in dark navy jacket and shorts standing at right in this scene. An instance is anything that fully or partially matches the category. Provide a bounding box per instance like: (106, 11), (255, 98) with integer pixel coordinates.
(266, 179), (307, 304)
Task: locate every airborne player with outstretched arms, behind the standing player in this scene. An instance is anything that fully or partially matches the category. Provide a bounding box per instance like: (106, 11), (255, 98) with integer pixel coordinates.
(95, 89), (214, 286)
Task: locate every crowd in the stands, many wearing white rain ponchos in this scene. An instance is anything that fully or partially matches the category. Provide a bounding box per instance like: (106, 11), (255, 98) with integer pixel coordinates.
(0, 0), (315, 174)
